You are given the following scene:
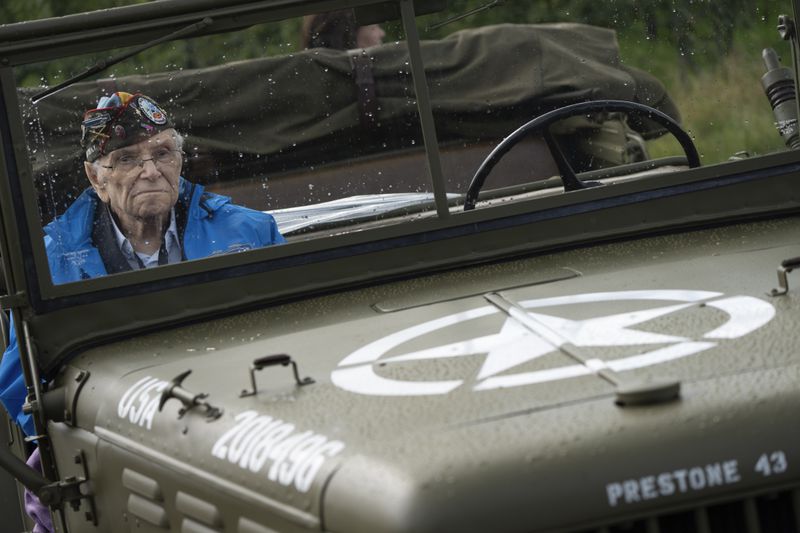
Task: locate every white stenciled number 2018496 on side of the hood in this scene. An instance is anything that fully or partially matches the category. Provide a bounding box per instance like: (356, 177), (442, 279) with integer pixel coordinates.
(211, 411), (344, 492)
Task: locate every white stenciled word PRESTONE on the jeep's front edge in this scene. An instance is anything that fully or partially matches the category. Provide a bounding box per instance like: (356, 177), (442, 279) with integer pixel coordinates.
(606, 459), (744, 507)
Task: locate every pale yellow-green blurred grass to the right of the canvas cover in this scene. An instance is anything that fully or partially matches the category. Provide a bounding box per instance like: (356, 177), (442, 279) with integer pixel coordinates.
(620, 24), (791, 165)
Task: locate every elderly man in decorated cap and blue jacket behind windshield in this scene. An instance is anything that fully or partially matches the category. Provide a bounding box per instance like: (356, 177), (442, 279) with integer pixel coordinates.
(0, 92), (285, 531)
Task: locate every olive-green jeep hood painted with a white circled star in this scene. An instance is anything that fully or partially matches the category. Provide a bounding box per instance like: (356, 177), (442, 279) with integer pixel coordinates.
(64, 218), (800, 531)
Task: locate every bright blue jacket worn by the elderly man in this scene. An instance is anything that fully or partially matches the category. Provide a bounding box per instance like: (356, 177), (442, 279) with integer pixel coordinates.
(0, 178), (285, 435)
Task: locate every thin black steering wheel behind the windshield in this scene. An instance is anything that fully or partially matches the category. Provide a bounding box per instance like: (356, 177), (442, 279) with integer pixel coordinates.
(464, 100), (700, 211)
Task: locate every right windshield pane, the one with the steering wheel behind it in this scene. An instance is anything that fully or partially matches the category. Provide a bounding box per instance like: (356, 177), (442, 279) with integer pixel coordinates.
(419, 0), (796, 201)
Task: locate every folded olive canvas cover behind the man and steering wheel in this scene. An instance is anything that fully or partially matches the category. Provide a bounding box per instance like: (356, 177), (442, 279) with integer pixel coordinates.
(19, 24), (678, 212)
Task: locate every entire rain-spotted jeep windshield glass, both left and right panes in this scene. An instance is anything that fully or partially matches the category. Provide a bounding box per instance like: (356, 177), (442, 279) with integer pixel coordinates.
(9, 0), (797, 284)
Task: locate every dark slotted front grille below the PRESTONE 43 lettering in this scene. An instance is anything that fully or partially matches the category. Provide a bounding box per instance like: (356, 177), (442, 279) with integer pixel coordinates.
(581, 489), (800, 533)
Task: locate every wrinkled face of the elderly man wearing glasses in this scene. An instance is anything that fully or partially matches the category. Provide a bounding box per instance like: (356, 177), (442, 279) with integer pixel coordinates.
(85, 129), (183, 225)
